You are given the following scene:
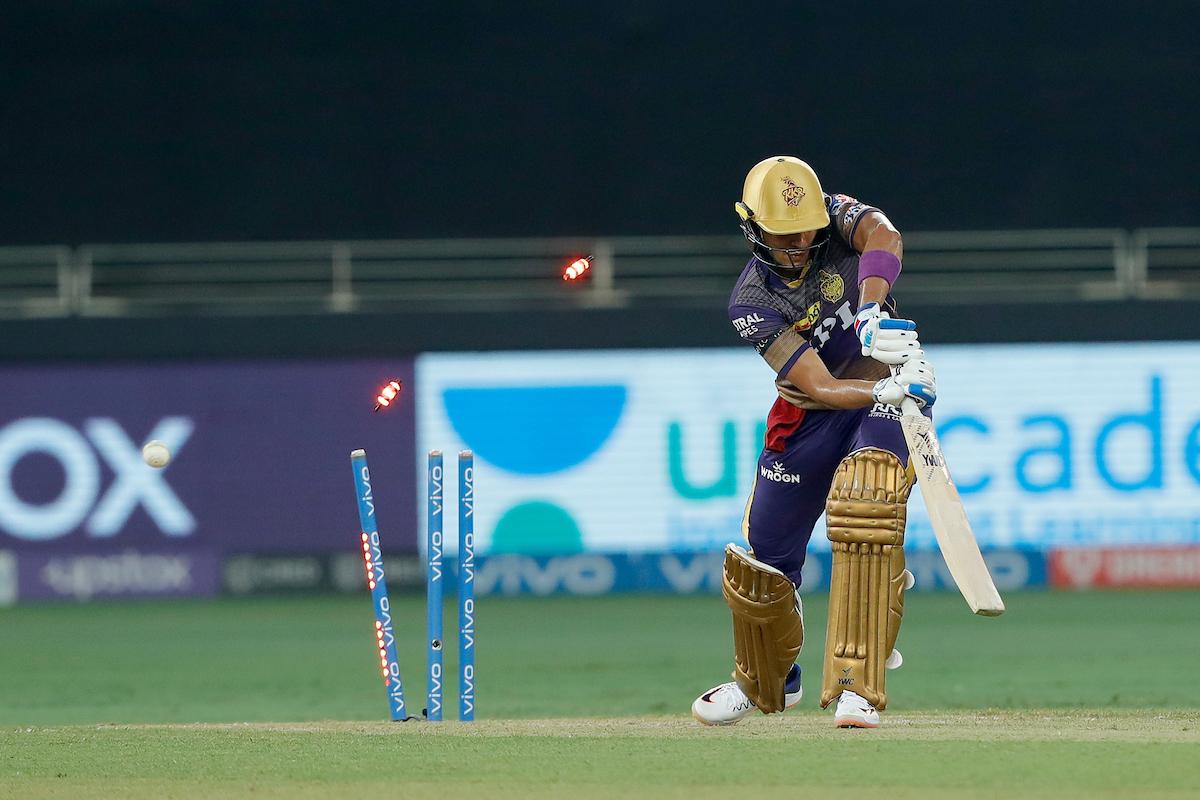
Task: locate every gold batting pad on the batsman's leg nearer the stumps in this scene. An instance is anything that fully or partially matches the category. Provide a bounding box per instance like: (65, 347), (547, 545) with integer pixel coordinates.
(721, 545), (804, 714)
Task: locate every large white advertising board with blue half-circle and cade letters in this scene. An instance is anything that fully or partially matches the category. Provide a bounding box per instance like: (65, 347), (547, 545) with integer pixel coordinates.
(416, 343), (1200, 554)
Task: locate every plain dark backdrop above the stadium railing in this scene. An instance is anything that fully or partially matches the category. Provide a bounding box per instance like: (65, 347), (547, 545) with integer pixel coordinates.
(0, 0), (1200, 245)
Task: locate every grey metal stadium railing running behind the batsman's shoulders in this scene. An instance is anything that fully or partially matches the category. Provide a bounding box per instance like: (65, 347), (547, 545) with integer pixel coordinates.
(0, 228), (1200, 317)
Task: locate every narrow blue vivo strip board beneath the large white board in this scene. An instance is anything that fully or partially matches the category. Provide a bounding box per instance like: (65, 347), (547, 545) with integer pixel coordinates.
(446, 549), (1046, 595)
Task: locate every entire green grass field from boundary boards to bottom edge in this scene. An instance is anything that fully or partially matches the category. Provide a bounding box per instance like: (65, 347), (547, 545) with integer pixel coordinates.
(0, 593), (1200, 798)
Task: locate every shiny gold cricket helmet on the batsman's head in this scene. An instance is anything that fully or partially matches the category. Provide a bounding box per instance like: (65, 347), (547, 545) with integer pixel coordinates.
(733, 156), (829, 234)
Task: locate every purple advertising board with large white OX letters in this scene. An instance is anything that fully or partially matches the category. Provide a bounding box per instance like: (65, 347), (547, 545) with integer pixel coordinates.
(0, 360), (415, 556)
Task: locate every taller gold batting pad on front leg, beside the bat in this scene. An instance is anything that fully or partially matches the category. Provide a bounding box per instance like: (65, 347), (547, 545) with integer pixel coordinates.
(821, 449), (912, 710)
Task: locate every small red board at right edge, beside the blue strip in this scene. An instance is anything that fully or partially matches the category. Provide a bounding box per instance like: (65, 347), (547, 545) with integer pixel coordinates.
(1049, 545), (1200, 589)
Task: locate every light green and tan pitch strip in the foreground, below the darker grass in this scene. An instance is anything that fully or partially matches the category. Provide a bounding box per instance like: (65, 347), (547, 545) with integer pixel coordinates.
(7, 711), (1200, 800)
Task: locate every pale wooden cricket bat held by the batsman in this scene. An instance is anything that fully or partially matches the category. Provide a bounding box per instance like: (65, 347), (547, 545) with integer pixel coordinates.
(900, 397), (1004, 616)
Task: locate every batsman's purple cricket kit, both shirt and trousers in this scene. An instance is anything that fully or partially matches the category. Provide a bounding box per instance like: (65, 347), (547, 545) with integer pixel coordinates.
(730, 194), (928, 587)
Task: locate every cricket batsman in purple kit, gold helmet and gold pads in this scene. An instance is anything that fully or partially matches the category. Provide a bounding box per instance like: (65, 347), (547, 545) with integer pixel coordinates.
(692, 156), (937, 728)
